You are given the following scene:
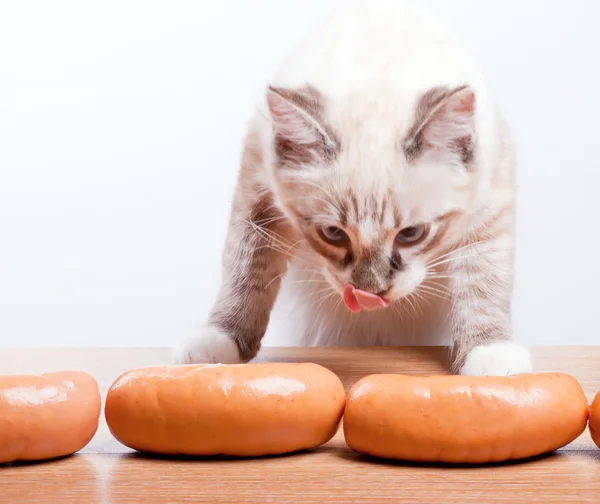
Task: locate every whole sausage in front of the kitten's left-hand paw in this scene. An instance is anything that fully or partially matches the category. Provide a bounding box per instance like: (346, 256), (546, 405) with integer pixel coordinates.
(105, 363), (346, 457)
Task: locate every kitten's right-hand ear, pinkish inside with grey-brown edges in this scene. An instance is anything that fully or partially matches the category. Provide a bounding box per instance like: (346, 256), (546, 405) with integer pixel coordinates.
(403, 86), (475, 165)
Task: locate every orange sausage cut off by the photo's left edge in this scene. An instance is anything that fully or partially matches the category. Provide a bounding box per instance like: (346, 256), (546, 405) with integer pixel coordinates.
(0, 371), (101, 463)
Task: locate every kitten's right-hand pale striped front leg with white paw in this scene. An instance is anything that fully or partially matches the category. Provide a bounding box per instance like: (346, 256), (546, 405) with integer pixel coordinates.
(448, 219), (532, 376)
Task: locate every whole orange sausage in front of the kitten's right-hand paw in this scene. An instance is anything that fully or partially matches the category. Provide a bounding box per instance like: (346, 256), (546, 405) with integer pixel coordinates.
(344, 373), (588, 463)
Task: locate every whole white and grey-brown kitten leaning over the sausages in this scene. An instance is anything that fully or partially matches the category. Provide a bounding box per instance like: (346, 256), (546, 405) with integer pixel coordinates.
(174, 0), (532, 375)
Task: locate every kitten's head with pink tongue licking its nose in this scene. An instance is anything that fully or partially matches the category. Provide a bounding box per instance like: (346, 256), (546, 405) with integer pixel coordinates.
(267, 83), (475, 311)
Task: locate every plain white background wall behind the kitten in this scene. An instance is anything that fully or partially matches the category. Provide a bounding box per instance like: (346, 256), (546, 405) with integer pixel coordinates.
(0, 0), (600, 346)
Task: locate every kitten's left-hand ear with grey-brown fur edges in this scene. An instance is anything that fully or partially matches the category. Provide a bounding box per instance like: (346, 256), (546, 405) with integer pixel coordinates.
(267, 87), (339, 166)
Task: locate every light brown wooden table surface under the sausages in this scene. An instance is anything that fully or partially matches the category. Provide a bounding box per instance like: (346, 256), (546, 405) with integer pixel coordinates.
(0, 347), (600, 504)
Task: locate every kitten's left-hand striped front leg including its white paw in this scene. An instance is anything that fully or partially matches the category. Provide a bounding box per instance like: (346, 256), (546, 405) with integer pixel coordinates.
(173, 196), (291, 364)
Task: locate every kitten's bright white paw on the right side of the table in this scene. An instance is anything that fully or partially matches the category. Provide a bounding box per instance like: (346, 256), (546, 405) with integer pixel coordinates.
(460, 341), (533, 376)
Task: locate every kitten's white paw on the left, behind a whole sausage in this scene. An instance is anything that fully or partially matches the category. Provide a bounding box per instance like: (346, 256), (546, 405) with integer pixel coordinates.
(172, 326), (241, 364)
